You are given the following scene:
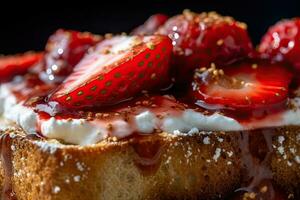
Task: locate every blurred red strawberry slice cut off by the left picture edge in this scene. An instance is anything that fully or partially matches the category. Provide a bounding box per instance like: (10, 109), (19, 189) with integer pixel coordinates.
(0, 52), (43, 82)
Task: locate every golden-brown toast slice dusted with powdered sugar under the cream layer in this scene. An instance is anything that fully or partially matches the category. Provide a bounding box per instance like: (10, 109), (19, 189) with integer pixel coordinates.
(0, 126), (300, 200)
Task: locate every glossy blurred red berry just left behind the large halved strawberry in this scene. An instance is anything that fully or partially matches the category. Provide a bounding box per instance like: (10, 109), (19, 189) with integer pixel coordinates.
(42, 29), (101, 82)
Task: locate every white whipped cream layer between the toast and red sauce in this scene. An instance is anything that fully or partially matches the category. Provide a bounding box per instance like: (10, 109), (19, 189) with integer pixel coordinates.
(0, 84), (300, 145)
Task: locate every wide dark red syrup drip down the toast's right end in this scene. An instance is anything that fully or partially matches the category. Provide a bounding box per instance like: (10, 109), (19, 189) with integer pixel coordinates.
(231, 128), (287, 200)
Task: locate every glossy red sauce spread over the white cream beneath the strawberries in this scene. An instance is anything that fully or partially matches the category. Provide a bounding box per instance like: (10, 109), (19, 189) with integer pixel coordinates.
(5, 74), (287, 125)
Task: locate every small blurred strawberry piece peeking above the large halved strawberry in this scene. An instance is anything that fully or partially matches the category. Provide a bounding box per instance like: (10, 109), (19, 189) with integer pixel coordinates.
(132, 14), (169, 35)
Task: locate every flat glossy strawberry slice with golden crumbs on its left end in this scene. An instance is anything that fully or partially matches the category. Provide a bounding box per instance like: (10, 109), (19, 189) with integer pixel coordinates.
(192, 61), (292, 111)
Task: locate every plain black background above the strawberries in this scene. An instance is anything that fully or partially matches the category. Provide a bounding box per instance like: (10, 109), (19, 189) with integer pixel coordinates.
(0, 0), (300, 54)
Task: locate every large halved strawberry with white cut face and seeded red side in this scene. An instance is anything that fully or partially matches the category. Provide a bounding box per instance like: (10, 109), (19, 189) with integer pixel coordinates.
(50, 36), (172, 108)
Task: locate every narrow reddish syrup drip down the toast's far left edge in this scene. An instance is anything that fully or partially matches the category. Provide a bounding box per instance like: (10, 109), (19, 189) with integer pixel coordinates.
(0, 134), (17, 200)
